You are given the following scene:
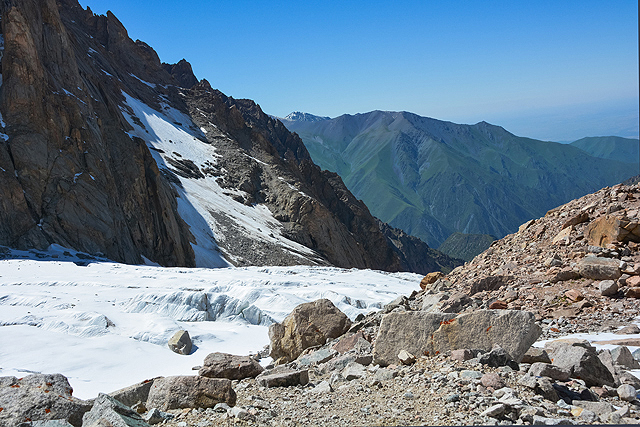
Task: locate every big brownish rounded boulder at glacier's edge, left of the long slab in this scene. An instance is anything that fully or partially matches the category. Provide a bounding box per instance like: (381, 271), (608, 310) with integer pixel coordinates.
(269, 299), (351, 362)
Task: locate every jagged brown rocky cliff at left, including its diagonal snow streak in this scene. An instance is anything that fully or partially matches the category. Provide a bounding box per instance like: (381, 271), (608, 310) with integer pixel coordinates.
(0, 0), (456, 272)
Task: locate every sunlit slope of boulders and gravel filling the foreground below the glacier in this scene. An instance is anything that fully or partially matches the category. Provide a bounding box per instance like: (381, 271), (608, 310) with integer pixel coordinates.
(0, 185), (640, 427)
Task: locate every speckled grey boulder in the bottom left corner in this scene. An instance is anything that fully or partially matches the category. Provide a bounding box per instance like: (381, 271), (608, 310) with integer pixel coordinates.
(0, 374), (91, 427)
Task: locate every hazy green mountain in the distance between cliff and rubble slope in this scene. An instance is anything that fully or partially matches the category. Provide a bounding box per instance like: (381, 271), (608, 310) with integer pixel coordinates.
(283, 111), (636, 247)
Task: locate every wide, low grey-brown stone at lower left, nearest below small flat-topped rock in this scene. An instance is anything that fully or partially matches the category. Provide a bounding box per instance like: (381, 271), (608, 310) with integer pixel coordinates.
(147, 376), (236, 411)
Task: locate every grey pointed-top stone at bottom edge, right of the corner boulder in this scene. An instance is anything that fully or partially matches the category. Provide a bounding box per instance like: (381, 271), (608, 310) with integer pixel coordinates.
(82, 393), (149, 427)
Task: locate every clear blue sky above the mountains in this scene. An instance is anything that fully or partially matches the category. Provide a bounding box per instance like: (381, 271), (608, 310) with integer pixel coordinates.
(80, 0), (639, 141)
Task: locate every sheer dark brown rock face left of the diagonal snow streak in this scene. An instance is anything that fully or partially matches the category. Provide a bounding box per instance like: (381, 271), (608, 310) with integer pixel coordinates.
(0, 0), (194, 266)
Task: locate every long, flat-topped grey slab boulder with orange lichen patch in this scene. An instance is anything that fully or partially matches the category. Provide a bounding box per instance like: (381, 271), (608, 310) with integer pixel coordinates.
(373, 310), (541, 366)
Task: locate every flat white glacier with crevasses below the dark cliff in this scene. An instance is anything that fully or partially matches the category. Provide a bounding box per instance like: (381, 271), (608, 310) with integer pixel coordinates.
(0, 248), (421, 398)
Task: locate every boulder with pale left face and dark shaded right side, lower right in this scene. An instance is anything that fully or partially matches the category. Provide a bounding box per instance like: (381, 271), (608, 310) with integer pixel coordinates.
(551, 342), (615, 387)
